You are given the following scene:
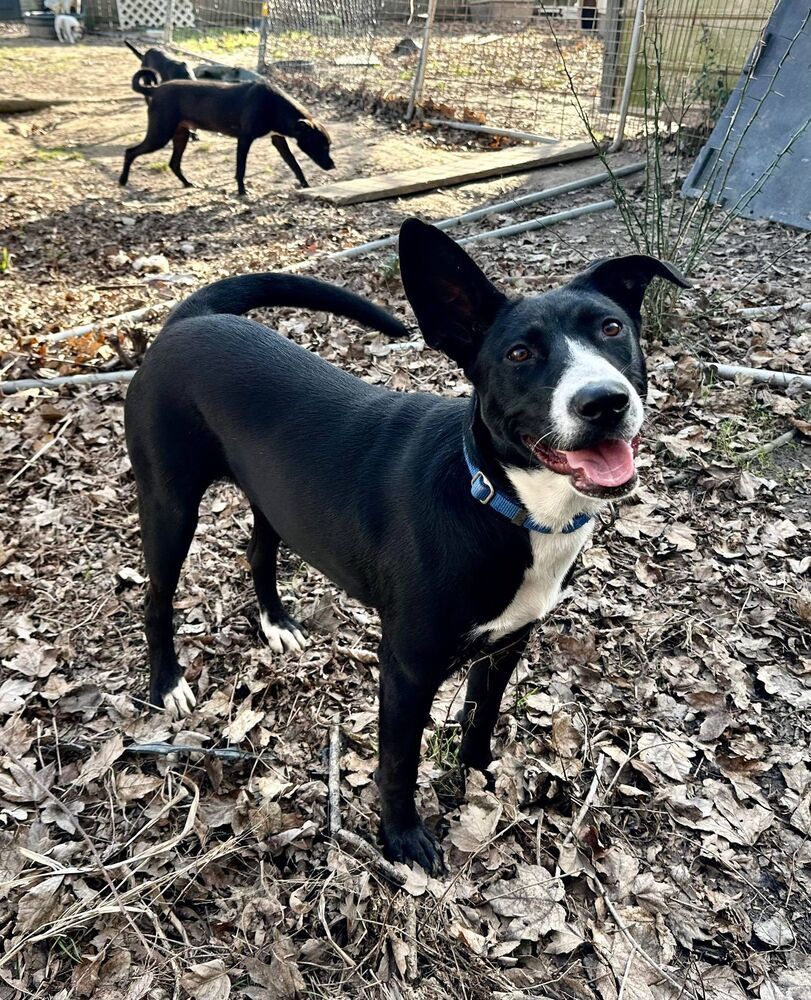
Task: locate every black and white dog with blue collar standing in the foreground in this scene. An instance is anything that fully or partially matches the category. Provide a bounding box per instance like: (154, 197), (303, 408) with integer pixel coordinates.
(126, 219), (686, 870)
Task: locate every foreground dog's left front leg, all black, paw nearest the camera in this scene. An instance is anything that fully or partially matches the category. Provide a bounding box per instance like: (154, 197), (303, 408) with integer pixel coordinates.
(376, 636), (446, 872)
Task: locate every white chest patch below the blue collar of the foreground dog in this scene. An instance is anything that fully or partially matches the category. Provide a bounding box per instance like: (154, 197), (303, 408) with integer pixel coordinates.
(474, 524), (592, 639)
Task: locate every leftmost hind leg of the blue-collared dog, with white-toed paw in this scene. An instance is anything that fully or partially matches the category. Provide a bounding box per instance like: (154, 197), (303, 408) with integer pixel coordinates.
(138, 481), (203, 717)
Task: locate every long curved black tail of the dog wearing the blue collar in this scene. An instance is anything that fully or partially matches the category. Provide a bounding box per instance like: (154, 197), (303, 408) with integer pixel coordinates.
(164, 271), (411, 337)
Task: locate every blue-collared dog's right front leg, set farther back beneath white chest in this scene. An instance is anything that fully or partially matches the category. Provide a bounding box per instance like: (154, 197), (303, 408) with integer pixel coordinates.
(459, 625), (532, 771)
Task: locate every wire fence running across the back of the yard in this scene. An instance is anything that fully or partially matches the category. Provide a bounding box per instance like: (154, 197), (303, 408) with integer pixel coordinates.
(6, 0), (773, 141)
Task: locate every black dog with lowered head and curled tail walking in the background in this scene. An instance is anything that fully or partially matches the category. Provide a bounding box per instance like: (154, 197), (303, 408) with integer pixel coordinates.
(118, 77), (335, 195)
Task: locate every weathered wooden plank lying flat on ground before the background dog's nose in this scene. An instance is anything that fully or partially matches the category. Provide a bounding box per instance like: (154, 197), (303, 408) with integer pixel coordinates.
(299, 142), (594, 205)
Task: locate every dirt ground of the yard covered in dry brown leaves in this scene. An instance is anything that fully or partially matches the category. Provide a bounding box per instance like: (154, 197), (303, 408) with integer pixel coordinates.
(0, 31), (811, 1000)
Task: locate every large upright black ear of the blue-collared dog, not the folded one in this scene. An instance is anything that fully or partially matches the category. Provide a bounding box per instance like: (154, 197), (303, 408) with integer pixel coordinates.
(400, 219), (507, 368)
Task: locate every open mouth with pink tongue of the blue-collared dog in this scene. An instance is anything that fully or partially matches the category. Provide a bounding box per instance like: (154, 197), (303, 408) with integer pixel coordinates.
(523, 434), (639, 496)
